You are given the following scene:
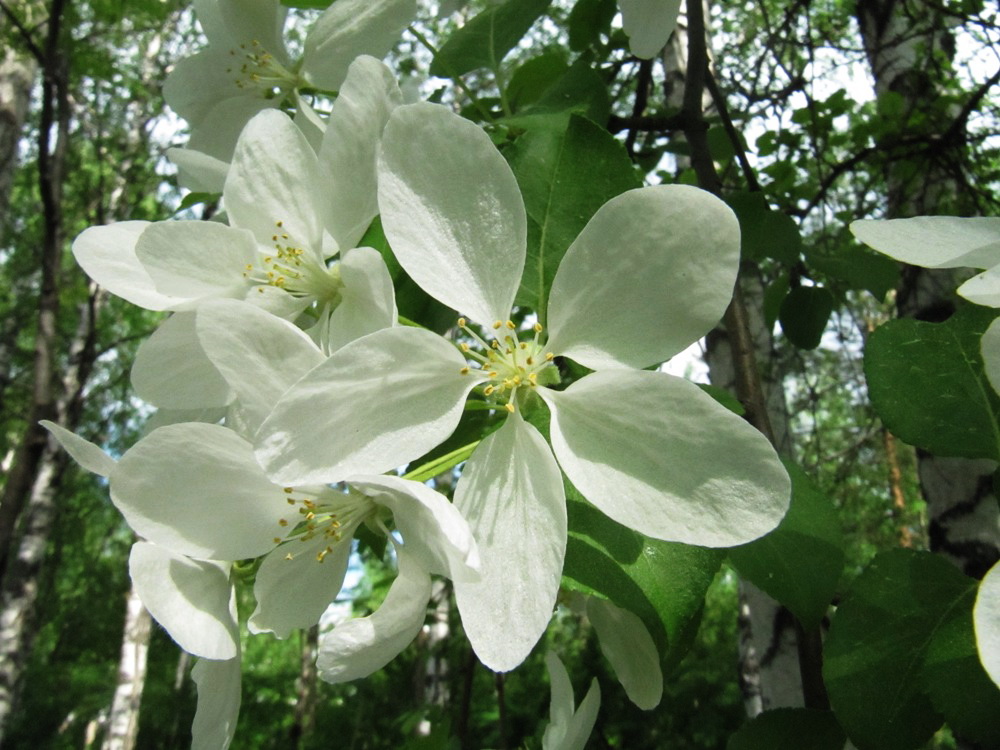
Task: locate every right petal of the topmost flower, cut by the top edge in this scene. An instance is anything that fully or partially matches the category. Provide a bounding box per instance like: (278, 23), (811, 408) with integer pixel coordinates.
(302, 0), (417, 90)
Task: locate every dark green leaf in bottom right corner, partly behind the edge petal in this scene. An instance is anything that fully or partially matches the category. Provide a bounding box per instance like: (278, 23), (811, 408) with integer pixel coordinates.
(924, 584), (1000, 747)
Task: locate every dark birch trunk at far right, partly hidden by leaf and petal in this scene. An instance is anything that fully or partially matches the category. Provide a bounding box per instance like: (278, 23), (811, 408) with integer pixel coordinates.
(857, 0), (1000, 578)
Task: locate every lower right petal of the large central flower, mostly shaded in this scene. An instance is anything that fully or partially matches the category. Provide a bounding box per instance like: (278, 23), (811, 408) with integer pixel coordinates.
(539, 370), (791, 547)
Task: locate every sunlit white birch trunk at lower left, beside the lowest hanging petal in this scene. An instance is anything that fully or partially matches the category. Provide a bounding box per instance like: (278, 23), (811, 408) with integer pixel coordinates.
(101, 586), (152, 750)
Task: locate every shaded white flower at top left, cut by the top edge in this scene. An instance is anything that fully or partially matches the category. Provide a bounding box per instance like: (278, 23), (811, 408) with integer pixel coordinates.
(163, 0), (416, 162)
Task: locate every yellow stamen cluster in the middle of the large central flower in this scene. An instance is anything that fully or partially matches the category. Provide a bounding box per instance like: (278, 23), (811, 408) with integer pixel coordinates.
(458, 318), (554, 413)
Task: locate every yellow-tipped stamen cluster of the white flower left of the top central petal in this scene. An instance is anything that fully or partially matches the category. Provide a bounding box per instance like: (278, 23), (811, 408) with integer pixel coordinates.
(243, 221), (344, 306)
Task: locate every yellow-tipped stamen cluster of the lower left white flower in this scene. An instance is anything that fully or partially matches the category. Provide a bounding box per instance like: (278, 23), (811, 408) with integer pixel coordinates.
(274, 487), (376, 562)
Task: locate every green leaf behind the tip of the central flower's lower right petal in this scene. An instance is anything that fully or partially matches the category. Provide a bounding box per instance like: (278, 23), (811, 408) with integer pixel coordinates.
(729, 461), (844, 630)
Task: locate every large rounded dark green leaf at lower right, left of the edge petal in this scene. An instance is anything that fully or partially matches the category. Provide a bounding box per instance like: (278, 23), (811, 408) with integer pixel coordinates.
(823, 550), (975, 750)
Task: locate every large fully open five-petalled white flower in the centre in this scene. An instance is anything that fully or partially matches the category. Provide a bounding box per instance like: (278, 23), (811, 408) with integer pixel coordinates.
(257, 104), (790, 670)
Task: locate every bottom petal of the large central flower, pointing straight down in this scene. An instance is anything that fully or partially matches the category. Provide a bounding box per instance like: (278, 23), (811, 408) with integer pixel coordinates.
(455, 414), (566, 672)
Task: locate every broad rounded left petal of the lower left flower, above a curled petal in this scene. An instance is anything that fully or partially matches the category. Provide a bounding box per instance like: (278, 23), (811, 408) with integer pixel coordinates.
(111, 422), (289, 560)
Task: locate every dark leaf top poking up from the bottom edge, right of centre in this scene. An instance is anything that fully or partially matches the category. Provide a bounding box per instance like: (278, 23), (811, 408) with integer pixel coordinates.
(726, 708), (847, 750)
